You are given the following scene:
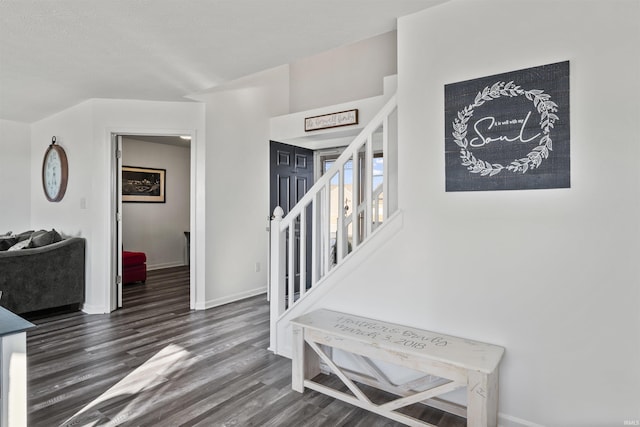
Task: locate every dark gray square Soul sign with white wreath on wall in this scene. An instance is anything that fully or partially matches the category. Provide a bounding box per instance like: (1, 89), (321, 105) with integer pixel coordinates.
(444, 61), (571, 191)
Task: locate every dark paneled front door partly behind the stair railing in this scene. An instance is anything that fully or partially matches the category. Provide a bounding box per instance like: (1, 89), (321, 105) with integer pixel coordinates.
(269, 141), (313, 292)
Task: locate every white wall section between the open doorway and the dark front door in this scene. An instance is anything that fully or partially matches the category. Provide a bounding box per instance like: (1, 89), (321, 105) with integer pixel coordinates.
(190, 66), (289, 308)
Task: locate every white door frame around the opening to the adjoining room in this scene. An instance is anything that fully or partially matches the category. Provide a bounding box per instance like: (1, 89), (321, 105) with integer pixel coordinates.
(109, 128), (200, 311)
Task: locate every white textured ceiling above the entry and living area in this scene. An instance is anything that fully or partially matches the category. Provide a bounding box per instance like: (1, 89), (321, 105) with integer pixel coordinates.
(0, 0), (446, 122)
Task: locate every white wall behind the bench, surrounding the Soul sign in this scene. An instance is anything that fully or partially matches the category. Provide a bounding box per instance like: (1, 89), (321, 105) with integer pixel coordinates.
(298, 0), (640, 426)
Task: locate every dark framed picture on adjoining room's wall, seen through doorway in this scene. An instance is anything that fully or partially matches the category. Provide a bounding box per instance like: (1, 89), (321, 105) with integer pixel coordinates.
(122, 166), (167, 203)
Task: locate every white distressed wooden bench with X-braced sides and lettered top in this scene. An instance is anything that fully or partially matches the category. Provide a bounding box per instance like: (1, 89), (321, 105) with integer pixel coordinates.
(291, 310), (504, 426)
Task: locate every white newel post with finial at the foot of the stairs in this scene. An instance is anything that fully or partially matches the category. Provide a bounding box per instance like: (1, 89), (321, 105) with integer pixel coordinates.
(270, 206), (286, 354)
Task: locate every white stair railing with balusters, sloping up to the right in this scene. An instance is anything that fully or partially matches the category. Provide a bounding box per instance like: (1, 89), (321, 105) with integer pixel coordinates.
(270, 96), (398, 351)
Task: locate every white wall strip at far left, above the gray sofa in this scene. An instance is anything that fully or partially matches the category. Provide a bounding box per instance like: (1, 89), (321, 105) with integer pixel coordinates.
(0, 120), (31, 234)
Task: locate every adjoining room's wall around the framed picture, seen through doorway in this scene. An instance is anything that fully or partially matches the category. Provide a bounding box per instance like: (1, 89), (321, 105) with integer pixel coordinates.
(122, 137), (191, 270)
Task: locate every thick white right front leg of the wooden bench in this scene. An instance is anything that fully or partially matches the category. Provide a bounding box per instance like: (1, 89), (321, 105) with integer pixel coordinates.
(467, 371), (498, 427)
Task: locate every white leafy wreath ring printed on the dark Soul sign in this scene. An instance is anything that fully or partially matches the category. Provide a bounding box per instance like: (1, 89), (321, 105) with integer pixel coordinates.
(453, 81), (559, 176)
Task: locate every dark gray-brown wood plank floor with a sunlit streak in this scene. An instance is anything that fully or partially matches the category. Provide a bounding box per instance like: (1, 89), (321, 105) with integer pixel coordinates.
(27, 267), (466, 427)
